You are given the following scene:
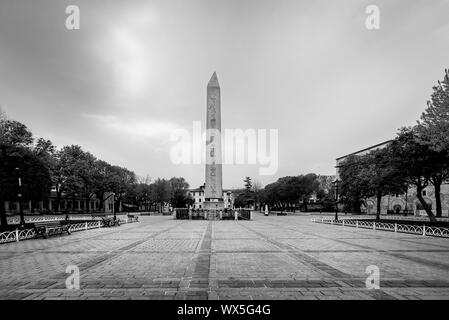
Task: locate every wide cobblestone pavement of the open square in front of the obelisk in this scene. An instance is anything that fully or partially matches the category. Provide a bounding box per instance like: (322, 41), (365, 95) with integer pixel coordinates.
(0, 213), (449, 300)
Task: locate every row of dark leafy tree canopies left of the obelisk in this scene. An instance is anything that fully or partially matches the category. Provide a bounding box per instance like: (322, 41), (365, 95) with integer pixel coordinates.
(0, 110), (189, 225)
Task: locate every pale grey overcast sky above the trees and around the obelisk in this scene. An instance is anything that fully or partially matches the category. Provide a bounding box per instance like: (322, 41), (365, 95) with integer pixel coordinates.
(0, 0), (449, 188)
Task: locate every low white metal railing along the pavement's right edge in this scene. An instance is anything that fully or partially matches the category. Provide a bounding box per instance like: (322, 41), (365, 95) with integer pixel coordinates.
(312, 218), (449, 238)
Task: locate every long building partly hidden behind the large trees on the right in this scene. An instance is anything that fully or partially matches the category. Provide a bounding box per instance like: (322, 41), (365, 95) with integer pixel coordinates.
(336, 140), (449, 217)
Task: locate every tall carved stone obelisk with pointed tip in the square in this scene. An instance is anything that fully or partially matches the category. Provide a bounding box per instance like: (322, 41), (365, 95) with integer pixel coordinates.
(204, 72), (224, 210)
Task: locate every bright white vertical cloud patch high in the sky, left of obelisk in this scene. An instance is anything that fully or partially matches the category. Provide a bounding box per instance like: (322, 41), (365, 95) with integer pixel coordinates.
(86, 5), (160, 98)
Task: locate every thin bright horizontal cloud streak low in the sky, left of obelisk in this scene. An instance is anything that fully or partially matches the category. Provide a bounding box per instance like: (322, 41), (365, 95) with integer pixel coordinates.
(83, 114), (178, 139)
